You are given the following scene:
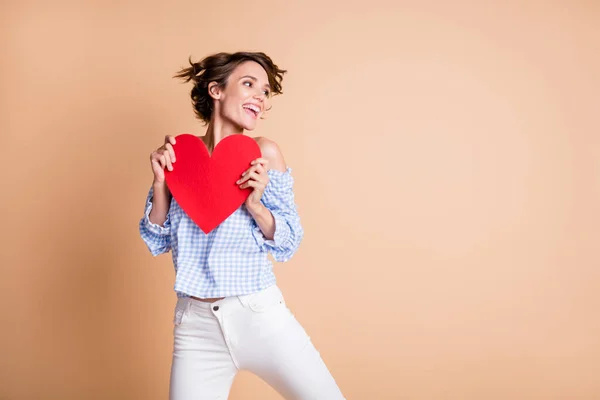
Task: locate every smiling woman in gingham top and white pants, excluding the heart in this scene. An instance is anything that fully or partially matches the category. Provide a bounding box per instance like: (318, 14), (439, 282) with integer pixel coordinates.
(140, 52), (344, 400)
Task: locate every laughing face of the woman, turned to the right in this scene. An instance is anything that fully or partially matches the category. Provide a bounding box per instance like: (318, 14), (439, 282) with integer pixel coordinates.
(209, 61), (271, 131)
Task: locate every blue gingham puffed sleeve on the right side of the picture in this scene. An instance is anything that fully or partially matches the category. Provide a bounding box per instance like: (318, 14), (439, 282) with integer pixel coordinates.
(252, 168), (304, 262)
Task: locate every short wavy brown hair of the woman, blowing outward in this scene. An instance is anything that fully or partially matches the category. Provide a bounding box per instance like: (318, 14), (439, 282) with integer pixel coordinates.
(173, 52), (287, 124)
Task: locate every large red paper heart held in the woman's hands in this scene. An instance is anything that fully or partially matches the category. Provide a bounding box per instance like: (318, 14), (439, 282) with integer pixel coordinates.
(165, 133), (261, 234)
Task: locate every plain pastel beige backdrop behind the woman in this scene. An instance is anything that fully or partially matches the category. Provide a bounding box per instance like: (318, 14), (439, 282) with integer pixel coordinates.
(0, 0), (600, 400)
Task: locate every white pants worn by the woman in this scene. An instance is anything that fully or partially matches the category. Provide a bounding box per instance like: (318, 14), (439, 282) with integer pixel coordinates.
(170, 285), (344, 400)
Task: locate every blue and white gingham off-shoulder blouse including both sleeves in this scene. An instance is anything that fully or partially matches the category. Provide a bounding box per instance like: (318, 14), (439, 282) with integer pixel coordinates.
(139, 168), (304, 298)
